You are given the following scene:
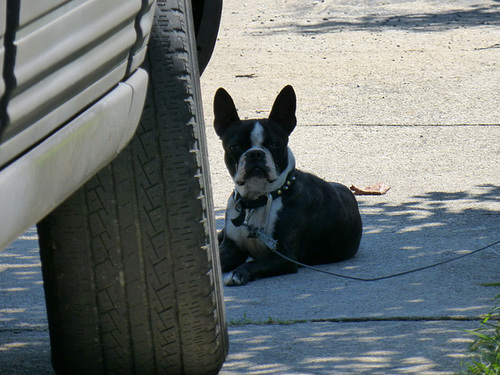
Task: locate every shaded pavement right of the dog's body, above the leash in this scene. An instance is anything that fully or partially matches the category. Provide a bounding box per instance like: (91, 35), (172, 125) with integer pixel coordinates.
(216, 184), (500, 284)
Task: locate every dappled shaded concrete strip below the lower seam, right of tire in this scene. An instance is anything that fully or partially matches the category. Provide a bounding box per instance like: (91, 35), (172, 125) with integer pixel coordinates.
(221, 321), (475, 375)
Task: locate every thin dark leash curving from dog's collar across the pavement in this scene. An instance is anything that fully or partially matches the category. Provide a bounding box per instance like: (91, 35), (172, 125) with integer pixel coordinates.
(244, 224), (500, 281)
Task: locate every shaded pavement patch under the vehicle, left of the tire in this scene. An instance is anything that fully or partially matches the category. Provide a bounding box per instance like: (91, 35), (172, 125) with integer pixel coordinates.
(0, 227), (54, 375)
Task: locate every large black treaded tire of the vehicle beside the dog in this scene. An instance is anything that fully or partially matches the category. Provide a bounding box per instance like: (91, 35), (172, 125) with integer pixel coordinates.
(38, 0), (228, 375)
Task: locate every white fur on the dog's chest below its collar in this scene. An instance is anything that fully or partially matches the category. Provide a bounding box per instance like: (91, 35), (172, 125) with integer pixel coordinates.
(225, 197), (283, 259)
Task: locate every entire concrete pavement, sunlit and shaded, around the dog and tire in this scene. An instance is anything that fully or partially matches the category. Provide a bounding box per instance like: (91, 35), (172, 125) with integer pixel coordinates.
(0, 0), (500, 375)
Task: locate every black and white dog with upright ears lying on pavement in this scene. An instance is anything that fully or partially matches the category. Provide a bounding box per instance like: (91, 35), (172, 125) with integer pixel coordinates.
(214, 86), (362, 285)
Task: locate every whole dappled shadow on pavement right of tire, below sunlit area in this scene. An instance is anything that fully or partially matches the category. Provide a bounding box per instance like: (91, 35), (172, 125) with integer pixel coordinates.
(221, 184), (500, 375)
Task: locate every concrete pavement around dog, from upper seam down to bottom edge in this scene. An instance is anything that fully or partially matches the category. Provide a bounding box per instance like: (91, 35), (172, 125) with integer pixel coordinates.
(211, 125), (500, 374)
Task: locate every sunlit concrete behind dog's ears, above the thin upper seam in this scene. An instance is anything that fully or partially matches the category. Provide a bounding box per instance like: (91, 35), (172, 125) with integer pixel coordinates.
(199, 0), (500, 125)
